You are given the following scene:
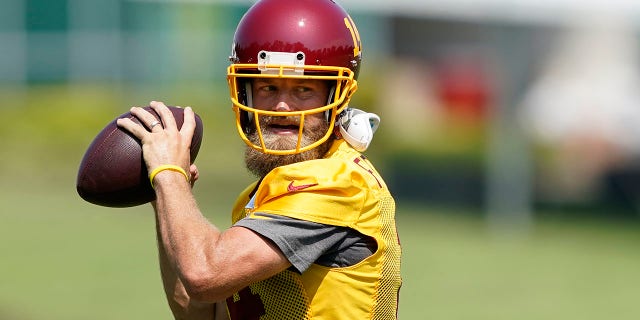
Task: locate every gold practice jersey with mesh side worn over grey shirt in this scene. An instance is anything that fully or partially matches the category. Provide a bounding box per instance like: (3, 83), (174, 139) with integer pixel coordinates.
(227, 140), (402, 320)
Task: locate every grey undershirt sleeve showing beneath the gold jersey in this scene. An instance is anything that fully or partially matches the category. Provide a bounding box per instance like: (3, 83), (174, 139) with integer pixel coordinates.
(235, 213), (375, 273)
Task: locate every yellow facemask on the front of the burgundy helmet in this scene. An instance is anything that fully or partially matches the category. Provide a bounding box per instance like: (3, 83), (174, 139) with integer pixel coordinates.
(227, 51), (357, 155)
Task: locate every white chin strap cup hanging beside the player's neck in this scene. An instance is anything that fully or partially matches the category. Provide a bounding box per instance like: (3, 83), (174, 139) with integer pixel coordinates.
(336, 108), (380, 152)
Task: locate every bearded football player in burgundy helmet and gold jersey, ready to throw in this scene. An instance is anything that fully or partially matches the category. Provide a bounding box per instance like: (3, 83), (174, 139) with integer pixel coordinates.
(118, 0), (401, 320)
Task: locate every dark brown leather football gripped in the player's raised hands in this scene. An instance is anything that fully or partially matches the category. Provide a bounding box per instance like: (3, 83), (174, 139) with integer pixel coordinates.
(76, 107), (202, 208)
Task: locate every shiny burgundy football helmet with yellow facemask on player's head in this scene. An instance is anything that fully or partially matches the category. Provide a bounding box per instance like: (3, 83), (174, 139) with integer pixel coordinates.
(227, 0), (362, 155)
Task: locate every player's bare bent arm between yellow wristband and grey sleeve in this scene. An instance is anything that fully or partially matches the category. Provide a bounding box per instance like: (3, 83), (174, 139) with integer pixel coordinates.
(155, 172), (290, 303)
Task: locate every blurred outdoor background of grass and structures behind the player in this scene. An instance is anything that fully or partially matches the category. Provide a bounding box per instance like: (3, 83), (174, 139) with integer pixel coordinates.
(0, 0), (640, 320)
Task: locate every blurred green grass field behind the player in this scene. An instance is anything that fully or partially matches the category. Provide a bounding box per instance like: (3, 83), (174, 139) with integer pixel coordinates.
(0, 84), (640, 320)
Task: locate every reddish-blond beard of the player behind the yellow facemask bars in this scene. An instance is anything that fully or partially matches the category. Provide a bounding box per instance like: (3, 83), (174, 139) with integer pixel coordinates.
(244, 117), (335, 178)
